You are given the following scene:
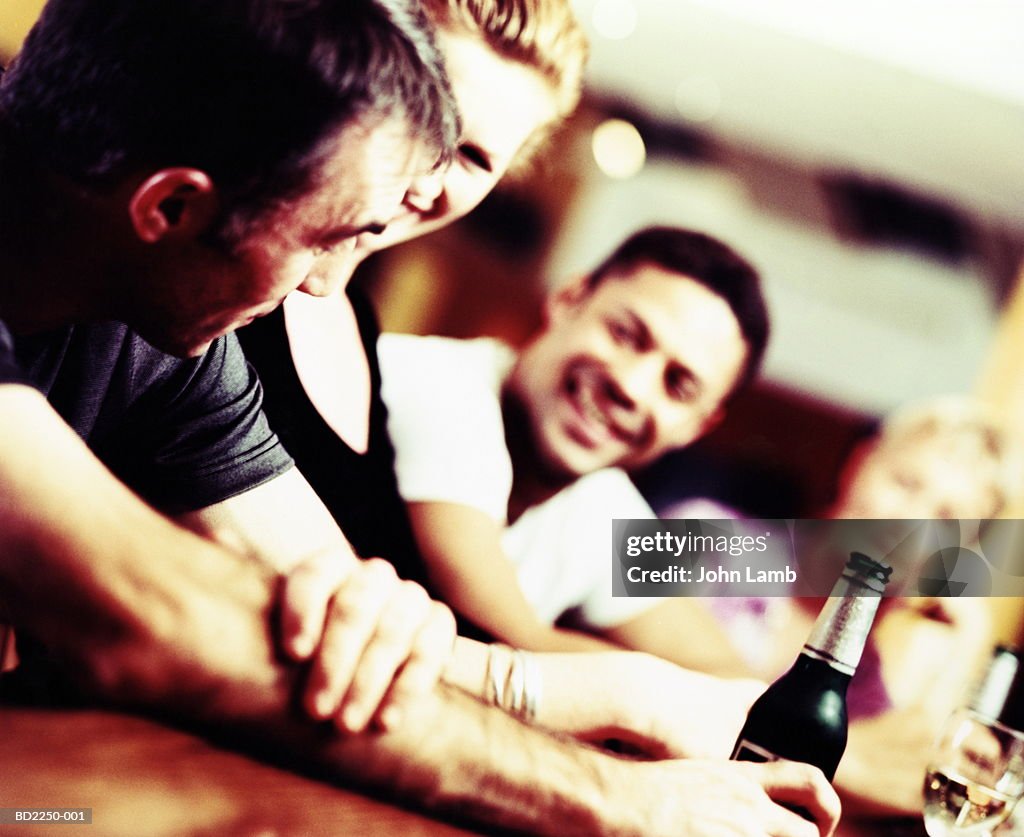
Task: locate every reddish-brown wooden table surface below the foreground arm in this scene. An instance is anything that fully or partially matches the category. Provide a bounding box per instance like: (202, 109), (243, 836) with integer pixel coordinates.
(0, 707), (479, 837)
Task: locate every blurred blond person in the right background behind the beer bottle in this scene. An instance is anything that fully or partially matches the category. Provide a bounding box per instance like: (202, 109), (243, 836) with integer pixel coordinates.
(674, 395), (1018, 814)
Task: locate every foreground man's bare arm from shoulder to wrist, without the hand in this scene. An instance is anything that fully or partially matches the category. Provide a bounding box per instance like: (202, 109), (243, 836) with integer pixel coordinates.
(0, 390), (611, 834)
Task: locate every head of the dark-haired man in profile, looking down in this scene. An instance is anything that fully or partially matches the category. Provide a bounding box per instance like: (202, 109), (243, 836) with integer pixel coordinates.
(0, 0), (459, 355)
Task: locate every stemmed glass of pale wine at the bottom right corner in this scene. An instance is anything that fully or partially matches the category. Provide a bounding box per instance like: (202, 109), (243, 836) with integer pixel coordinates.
(925, 709), (1024, 837)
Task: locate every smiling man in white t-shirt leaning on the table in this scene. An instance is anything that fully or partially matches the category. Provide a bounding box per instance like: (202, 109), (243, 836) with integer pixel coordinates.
(380, 227), (768, 655)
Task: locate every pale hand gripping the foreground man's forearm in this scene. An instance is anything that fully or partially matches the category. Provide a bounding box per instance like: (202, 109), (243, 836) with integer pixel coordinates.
(281, 552), (455, 733)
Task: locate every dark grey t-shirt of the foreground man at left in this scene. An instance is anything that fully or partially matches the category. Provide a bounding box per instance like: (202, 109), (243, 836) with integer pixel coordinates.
(0, 321), (292, 513)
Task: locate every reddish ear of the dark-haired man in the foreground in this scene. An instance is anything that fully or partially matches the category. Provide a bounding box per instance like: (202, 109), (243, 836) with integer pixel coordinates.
(128, 168), (217, 244)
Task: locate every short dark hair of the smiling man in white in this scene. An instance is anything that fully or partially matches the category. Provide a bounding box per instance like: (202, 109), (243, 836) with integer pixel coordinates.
(588, 226), (770, 397)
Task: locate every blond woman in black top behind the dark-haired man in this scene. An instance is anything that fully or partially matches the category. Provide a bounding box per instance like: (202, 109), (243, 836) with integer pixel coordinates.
(240, 0), (587, 580)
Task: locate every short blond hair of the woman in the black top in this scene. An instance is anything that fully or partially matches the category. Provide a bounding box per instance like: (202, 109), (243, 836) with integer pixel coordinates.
(423, 0), (589, 158)
